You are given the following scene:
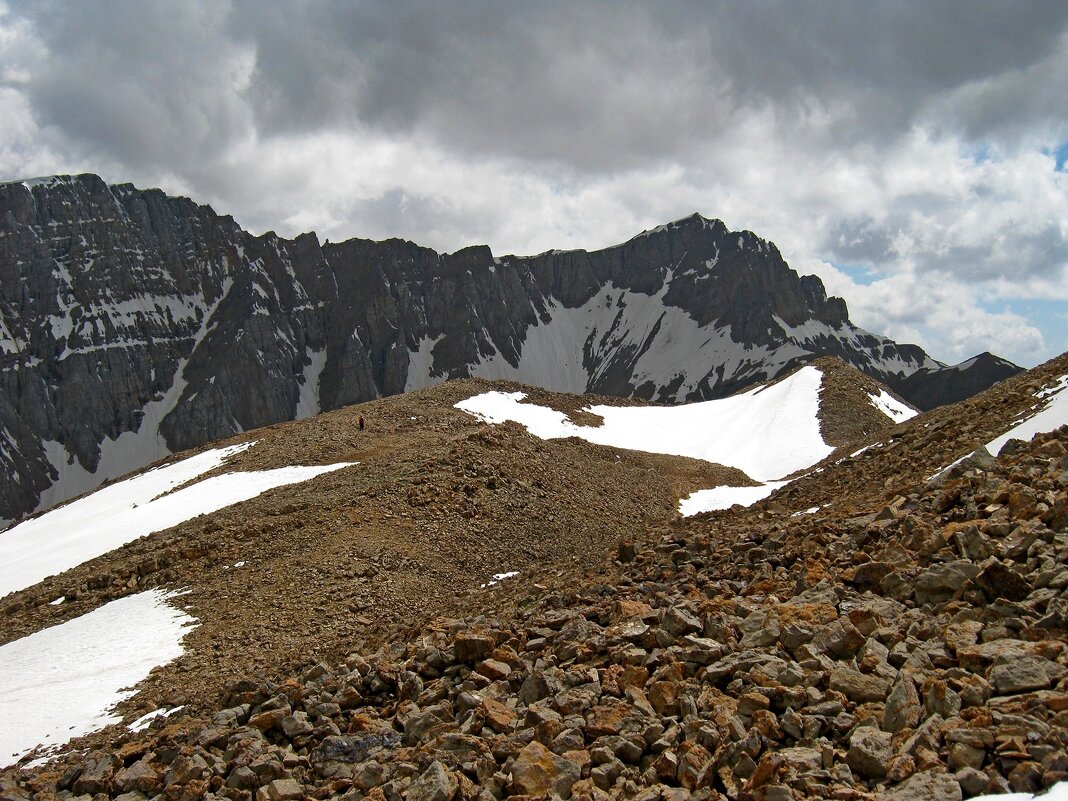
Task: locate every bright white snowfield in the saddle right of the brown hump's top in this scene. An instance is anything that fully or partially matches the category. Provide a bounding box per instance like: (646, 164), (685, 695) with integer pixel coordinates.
(456, 365), (834, 514)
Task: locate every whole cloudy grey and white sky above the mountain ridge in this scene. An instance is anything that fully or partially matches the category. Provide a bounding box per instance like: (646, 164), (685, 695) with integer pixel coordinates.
(0, 0), (1068, 366)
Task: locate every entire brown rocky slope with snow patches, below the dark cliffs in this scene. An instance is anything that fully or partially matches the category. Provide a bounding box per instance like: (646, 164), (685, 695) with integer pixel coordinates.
(0, 356), (1068, 801)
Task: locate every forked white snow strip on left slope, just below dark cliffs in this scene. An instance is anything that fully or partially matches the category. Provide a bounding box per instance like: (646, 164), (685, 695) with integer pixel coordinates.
(0, 442), (350, 598)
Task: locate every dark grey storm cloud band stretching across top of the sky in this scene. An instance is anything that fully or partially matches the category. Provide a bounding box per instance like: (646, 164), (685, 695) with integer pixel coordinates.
(8, 0), (1068, 177)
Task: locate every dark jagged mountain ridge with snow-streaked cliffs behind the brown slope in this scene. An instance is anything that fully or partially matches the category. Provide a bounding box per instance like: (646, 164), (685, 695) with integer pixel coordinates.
(0, 175), (1012, 519)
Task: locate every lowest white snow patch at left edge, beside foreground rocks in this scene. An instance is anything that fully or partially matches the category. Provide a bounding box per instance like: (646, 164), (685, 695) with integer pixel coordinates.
(0, 590), (197, 768)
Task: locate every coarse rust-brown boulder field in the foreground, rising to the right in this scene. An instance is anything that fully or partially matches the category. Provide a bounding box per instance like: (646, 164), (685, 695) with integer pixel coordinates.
(0, 393), (1068, 801)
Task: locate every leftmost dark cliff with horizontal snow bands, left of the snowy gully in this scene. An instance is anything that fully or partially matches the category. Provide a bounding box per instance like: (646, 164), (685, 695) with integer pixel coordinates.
(0, 175), (240, 517)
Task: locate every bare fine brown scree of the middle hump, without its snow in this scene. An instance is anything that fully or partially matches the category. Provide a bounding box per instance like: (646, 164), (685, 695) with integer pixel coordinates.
(0, 360), (892, 711)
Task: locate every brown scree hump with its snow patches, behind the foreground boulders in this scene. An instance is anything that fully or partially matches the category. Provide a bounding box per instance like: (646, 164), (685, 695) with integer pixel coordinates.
(0, 360), (918, 768)
